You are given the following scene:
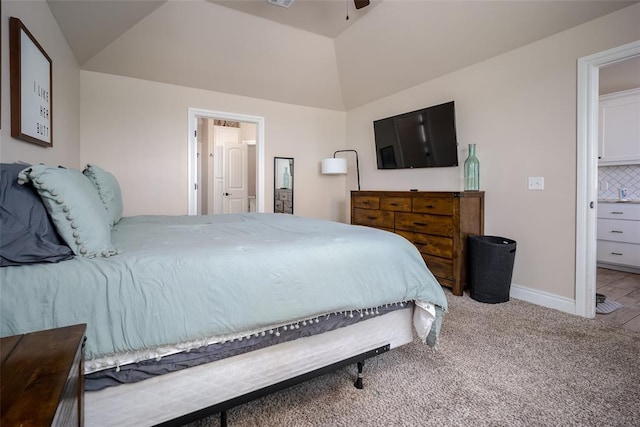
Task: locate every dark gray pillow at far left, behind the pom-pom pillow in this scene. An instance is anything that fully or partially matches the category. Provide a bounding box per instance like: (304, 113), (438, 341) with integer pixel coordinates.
(0, 163), (73, 267)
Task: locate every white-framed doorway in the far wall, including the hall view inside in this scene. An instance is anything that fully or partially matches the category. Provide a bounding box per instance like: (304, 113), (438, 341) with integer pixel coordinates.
(188, 108), (264, 215)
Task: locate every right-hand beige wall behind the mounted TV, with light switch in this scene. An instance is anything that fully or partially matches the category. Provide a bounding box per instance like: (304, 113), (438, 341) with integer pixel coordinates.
(347, 4), (640, 299)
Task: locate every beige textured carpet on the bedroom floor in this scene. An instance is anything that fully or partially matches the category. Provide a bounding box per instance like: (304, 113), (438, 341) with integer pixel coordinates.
(192, 294), (640, 427)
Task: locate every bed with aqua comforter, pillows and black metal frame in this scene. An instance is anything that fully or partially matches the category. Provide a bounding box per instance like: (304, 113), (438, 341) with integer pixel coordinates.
(0, 164), (447, 426)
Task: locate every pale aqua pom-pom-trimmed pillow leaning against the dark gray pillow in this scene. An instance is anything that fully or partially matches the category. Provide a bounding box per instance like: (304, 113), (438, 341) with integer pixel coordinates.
(18, 165), (116, 258)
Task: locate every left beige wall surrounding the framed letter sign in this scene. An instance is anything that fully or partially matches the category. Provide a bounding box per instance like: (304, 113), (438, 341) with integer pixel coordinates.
(0, 0), (80, 168)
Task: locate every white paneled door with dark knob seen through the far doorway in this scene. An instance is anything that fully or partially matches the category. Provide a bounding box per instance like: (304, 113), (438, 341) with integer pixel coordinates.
(214, 126), (249, 213)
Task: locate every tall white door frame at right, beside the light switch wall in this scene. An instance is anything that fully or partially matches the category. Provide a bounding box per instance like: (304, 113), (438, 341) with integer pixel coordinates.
(575, 40), (640, 318)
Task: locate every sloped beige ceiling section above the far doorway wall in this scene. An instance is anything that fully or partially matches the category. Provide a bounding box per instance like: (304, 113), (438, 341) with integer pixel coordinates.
(83, 0), (344, 110)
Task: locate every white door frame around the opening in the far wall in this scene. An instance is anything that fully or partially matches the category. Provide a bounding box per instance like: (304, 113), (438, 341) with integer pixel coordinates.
(187, 108), (265, 215)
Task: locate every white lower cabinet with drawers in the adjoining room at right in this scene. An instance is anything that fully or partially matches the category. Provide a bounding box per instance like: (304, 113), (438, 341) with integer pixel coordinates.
(597, 203), (640, 268)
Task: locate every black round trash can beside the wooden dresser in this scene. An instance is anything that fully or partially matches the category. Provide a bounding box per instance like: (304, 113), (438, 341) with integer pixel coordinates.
(467, 236), (516, 304)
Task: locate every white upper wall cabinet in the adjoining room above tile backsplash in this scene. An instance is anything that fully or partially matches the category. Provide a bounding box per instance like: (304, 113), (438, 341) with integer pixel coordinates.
(598, 88), (640, 165)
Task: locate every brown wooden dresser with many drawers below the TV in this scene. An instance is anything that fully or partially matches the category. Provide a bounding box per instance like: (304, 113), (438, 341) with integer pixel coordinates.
(351, 191), (484, 295)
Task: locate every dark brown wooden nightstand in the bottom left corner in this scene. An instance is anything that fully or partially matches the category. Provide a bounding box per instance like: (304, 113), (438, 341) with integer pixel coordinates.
(0, 324), (86, 426)
